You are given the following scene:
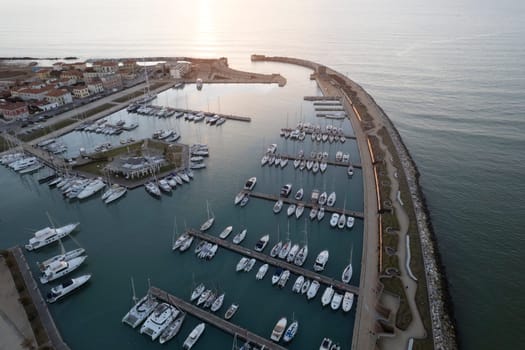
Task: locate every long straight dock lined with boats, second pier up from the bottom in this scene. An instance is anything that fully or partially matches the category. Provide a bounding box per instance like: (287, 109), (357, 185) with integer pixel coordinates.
(186, 228), (359, 295)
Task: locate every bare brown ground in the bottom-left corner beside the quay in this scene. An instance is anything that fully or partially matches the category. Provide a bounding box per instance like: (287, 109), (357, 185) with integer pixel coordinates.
(0, 258), (36, 350)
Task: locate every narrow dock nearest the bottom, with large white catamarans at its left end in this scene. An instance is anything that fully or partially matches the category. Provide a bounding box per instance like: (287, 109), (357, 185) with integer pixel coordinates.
(149, 287), (286, 350)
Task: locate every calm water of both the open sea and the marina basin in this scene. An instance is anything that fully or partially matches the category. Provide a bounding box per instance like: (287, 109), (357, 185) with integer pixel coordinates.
(0, 0), (525, 349)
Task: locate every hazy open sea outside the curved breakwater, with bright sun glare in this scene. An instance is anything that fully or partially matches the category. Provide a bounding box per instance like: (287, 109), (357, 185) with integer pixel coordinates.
(0, 0), (525, 349)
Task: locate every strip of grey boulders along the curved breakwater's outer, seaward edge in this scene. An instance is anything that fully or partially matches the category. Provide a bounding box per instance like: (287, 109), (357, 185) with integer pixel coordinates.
(354, 83), (458, 350)
